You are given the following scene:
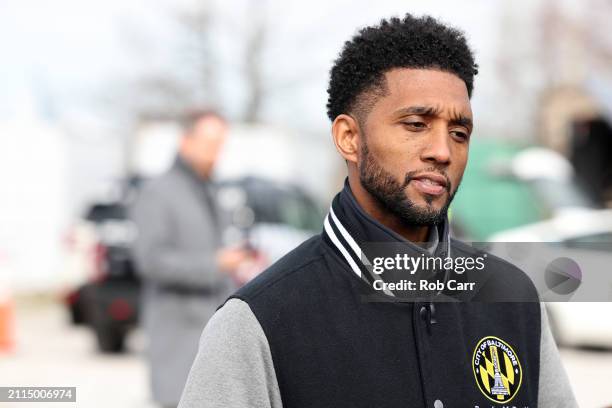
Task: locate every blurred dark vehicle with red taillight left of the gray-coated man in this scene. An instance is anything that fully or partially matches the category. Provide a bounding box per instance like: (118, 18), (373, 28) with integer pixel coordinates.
(59, 177), (141, 352)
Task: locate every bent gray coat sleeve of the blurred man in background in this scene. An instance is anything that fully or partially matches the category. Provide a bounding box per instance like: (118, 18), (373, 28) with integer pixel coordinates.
(130, 183), (219, 287)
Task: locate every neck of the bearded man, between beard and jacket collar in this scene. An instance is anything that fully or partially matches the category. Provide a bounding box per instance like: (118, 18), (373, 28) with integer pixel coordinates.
(349, 177), (430, 243)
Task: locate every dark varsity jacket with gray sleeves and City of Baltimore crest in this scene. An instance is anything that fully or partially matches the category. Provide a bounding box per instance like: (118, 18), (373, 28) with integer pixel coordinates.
(179, 183), (577, 408)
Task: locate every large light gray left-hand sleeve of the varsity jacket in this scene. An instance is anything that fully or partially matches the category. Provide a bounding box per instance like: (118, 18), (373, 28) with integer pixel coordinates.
(179, 299), (282, 408)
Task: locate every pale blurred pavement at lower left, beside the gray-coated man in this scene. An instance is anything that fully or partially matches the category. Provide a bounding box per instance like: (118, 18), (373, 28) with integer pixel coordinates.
(0, 299), (156, 408)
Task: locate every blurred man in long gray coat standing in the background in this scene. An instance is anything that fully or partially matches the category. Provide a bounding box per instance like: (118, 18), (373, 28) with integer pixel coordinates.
(131, 111), (248, 407)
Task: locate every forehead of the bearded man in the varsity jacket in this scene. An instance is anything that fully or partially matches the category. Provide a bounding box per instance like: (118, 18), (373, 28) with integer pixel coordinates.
(374, 68), (472, 117)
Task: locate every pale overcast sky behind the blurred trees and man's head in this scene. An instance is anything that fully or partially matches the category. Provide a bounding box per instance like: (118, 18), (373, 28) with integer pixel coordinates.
(0, 0), (596, 139)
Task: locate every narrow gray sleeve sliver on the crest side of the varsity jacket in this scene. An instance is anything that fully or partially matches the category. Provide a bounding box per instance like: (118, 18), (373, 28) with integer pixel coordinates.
(538, 302), (578, 408)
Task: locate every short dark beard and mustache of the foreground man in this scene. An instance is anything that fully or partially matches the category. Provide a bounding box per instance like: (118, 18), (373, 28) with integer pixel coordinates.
(359, 143), (457, 226)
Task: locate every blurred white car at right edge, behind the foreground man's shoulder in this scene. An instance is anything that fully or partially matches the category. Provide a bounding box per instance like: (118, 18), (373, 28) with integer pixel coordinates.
(490, 209), (612, 348)
